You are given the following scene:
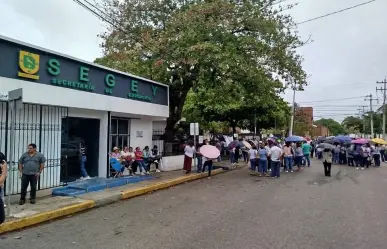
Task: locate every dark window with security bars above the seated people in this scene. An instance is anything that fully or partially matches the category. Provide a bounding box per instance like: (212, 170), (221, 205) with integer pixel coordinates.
(110, 117), (130, 151)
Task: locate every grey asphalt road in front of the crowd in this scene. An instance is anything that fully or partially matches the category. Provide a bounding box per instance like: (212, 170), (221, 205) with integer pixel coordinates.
(0, 161), (387, 249)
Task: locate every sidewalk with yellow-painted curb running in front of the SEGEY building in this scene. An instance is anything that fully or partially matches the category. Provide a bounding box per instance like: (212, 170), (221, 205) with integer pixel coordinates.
(0, 162), (245, 234)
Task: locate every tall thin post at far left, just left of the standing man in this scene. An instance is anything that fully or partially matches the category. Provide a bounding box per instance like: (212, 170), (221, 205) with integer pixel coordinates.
(7, 100), (16, 216)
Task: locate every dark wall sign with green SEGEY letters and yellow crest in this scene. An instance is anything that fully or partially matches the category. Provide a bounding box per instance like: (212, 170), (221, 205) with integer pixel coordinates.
(0, 38), (168, 105)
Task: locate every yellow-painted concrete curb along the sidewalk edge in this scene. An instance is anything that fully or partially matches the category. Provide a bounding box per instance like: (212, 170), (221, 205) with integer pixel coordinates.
(0, 169), (227, 234)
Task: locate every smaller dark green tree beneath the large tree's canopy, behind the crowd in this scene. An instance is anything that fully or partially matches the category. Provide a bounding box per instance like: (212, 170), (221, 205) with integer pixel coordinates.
(183, 78), (290, 133)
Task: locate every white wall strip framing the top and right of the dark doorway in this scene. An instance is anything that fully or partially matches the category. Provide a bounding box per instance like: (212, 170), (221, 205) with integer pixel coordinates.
(68, 108), (109, 177)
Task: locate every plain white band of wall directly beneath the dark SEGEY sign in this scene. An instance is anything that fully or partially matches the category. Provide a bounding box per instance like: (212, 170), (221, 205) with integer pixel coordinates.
(0, 77), (169, 118)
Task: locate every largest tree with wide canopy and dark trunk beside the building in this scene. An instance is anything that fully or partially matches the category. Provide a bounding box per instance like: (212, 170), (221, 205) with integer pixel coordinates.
(96, 0), (306, 140)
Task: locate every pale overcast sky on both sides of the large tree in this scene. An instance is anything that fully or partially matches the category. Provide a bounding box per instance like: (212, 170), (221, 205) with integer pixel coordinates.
(0, 0), (387, 121)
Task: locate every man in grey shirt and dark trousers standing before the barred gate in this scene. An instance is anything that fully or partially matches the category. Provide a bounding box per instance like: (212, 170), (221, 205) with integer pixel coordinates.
(19, 144), (46, 205)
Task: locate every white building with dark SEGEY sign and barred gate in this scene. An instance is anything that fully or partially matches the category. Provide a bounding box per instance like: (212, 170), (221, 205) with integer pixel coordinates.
(0, 37), (169, 193)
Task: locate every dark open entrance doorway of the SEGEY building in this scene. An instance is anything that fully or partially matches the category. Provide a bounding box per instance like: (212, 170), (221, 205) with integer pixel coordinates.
(60, 117), (100, 182)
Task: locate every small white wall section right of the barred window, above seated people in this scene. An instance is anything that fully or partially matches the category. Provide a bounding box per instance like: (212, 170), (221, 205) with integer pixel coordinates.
(130, 119), (153, 149)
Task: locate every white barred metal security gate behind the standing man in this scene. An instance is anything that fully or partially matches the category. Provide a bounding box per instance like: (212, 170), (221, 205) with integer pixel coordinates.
(0, 101), (68, 194)
